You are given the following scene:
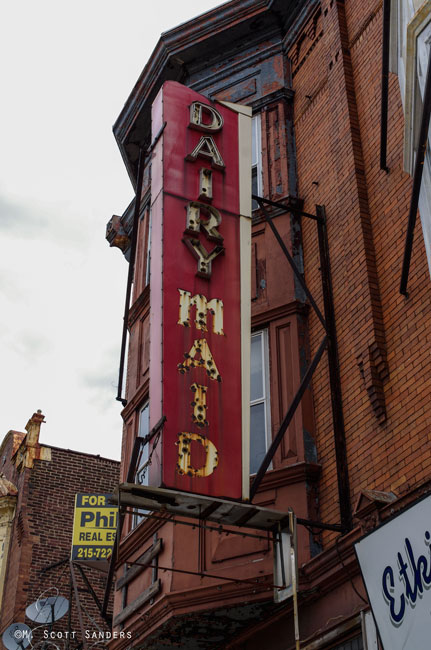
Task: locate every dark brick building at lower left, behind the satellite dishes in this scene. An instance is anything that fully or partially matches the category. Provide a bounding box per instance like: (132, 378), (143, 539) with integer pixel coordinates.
(0, 413), (119, 647)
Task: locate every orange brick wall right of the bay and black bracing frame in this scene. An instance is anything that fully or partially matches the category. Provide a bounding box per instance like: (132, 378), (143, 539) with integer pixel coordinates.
(289, 0), (431, 536)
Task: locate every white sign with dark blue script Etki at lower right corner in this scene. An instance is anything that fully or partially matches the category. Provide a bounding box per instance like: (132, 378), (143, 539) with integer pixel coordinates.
(355, 496), (431, 650)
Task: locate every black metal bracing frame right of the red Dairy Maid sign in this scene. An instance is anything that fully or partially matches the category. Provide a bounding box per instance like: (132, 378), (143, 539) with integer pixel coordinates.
(250, 195), (352, 531)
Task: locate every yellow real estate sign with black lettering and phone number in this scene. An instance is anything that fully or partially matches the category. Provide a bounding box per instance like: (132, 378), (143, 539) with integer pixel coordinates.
(72, 493), (118, 561)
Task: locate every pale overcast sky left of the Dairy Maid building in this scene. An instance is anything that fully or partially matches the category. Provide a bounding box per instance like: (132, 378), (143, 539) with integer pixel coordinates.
(0, 0), (226, 458)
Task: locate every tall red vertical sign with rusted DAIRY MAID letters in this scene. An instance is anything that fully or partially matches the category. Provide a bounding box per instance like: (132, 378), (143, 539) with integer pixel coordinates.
(150, 81), (251, 499)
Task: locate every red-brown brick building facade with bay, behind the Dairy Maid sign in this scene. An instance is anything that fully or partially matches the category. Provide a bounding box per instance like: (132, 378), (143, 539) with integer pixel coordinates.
(107, 0), (431, 650)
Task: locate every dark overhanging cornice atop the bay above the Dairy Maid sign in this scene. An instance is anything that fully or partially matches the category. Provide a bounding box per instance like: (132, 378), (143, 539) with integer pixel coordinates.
(113, 0), (310, 186)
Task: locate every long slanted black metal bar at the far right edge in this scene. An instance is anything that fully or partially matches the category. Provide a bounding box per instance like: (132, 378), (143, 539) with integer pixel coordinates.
(400, 48), (431, 298)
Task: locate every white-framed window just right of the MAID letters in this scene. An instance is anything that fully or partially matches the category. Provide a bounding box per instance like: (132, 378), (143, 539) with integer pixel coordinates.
(250, 330), (270, 474)
